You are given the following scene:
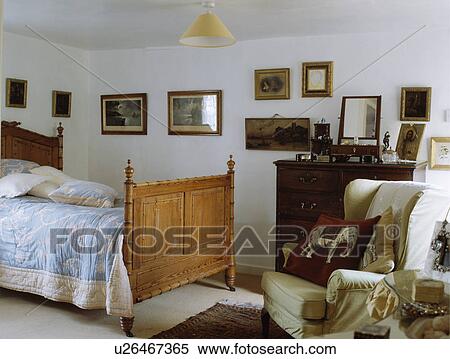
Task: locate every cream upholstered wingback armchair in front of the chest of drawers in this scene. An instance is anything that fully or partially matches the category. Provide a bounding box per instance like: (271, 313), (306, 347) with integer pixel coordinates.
(261, 180), (450, 338)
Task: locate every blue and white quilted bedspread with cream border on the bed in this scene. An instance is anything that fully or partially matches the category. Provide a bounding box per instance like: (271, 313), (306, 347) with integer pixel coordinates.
(0, 197), (133, 317)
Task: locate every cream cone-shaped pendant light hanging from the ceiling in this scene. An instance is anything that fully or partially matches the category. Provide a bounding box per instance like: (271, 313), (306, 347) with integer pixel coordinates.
(180, 1), (236, 47)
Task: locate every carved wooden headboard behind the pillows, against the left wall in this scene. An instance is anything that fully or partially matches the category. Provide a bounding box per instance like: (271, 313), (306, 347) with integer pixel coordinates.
(2, 121), (64, 170)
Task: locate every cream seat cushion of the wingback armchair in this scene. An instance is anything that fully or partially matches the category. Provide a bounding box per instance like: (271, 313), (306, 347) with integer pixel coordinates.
(261, 272), (327, 320)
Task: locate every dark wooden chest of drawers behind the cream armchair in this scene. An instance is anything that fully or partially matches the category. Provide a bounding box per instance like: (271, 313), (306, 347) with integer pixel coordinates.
(275, 160), (426, 270)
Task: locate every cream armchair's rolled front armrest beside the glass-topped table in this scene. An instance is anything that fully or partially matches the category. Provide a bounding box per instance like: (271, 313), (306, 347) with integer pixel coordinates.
(325, 269), (384, 332)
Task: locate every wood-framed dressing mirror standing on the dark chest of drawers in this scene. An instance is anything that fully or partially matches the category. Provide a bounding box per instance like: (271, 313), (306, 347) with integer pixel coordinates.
(331, 96), (381, 161)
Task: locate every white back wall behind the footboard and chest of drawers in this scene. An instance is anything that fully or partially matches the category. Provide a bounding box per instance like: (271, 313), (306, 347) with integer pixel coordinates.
(89, 28), (450, 267)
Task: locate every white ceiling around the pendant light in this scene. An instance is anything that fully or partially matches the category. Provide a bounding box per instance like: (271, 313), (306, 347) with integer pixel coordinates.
(5, 0), (450, 50)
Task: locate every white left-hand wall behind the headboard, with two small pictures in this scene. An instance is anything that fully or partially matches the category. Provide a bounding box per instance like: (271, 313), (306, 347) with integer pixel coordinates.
(2, 33), (89, 178)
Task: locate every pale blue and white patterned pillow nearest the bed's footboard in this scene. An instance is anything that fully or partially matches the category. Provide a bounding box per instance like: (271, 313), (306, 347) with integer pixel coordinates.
(49, 180), (119, 208)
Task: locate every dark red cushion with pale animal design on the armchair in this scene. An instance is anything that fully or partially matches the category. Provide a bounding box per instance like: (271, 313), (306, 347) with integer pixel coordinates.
(284, 215), (381, 287)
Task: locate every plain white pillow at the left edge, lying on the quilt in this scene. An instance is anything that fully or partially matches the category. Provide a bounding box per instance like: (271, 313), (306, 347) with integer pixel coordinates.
(0, 173), (47, 198)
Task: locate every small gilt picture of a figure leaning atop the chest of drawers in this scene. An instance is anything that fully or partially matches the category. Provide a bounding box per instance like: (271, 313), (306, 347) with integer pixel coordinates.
(396, 124), (425, 161)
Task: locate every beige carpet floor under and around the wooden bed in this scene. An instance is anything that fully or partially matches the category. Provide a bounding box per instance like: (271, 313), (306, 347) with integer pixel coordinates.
(0, 274), (263, 339)
